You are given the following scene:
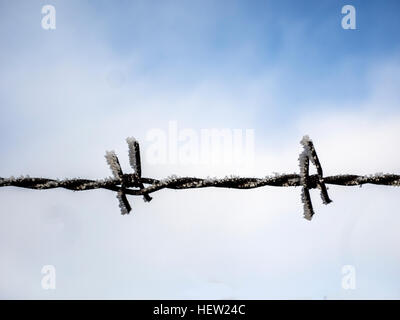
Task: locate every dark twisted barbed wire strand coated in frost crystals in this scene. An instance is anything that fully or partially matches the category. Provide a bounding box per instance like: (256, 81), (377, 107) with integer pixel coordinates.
(0, 136), (400, 220)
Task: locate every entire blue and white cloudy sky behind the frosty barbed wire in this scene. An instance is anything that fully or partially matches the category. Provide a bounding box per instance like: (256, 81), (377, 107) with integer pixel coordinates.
(0, 0), (400, 299)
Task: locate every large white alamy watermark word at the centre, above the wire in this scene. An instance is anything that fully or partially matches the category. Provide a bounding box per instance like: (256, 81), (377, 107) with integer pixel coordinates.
(145, 121), (255, 165)
